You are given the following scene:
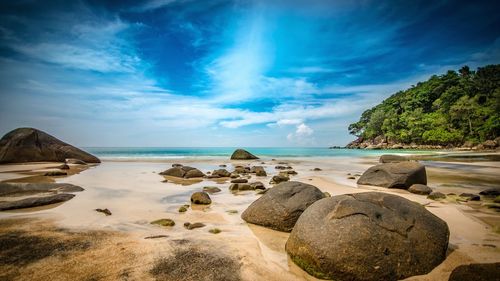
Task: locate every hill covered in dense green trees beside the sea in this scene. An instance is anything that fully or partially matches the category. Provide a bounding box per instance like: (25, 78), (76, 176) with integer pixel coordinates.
(349, 65), (500, 146)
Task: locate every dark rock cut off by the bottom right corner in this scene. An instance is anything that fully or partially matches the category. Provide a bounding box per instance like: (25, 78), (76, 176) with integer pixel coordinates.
(448, 262), (500, 281)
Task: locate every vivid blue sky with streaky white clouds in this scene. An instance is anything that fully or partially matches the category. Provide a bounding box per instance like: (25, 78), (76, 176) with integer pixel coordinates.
(0, 0), (500, 147)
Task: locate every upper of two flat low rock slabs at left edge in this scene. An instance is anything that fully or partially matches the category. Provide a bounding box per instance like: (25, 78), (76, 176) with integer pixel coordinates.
(0, 182), (84, 196)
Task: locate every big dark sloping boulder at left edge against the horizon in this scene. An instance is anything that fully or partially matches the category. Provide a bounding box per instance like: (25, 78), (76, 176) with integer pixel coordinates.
(0, 128), (101, 163)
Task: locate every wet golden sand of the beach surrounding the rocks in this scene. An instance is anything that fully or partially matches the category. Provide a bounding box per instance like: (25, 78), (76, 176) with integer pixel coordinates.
(0, 154), (500, 280)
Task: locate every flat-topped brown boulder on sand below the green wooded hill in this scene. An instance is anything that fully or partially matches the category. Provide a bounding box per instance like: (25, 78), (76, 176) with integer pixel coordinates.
(358, 162), (427, 189)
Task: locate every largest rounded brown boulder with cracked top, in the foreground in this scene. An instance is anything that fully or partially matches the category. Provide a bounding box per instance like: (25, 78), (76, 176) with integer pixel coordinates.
(285, 192), (450, 281)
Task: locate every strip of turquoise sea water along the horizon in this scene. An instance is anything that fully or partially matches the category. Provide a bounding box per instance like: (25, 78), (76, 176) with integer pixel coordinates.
(84, 147), (436, 159)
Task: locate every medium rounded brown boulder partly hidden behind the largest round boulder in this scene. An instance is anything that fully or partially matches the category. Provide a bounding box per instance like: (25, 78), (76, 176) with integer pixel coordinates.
(241, 181), (324, 232)
